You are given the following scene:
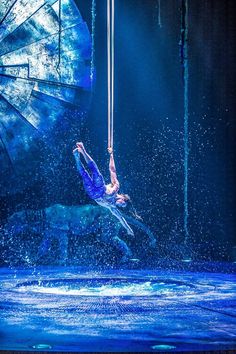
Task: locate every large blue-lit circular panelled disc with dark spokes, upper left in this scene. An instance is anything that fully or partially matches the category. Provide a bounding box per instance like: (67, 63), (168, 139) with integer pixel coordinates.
(0, 0), (92, 195)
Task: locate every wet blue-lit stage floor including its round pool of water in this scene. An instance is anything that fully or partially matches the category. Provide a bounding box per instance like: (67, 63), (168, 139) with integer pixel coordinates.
(0, 267), (236, 352)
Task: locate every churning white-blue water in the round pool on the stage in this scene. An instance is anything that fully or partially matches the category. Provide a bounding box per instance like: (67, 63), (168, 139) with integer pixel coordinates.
(15, 277), (197, 297)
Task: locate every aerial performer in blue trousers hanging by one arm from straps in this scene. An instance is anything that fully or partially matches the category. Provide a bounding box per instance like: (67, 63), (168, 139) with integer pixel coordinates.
(73, 143), (134, 236)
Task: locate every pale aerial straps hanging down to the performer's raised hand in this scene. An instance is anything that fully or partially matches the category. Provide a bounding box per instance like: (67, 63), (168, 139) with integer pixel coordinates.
(107, 0), (115, 149)
